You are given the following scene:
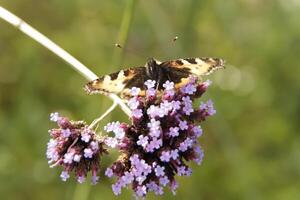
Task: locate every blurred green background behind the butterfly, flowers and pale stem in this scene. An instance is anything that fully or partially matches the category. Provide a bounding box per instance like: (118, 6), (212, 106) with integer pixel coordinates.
(0, 0), (300, 200)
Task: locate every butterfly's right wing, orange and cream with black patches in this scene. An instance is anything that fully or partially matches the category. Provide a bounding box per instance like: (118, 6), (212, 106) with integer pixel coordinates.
(160, 58), (225, 88)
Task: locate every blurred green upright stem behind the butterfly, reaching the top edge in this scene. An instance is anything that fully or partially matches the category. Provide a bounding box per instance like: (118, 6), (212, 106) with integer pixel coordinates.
(113, 0), (137, 67)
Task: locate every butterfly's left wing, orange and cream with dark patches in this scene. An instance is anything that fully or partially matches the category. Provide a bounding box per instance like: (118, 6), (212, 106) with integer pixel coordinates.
(85, 67), (147, 96)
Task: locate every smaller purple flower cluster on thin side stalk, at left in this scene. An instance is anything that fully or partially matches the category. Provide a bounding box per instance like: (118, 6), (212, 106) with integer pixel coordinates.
(46, 113), (107, 184)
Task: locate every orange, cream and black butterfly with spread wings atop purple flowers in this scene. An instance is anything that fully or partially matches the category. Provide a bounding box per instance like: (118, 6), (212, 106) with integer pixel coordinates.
(85, 58), (225, 99)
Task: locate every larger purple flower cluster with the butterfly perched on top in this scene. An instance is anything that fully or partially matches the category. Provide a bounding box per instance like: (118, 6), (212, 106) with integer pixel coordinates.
(105, 77), (216, 197)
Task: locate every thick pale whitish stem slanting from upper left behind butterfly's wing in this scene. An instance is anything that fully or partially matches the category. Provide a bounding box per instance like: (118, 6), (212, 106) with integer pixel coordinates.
(0, 6), (131, 116)
